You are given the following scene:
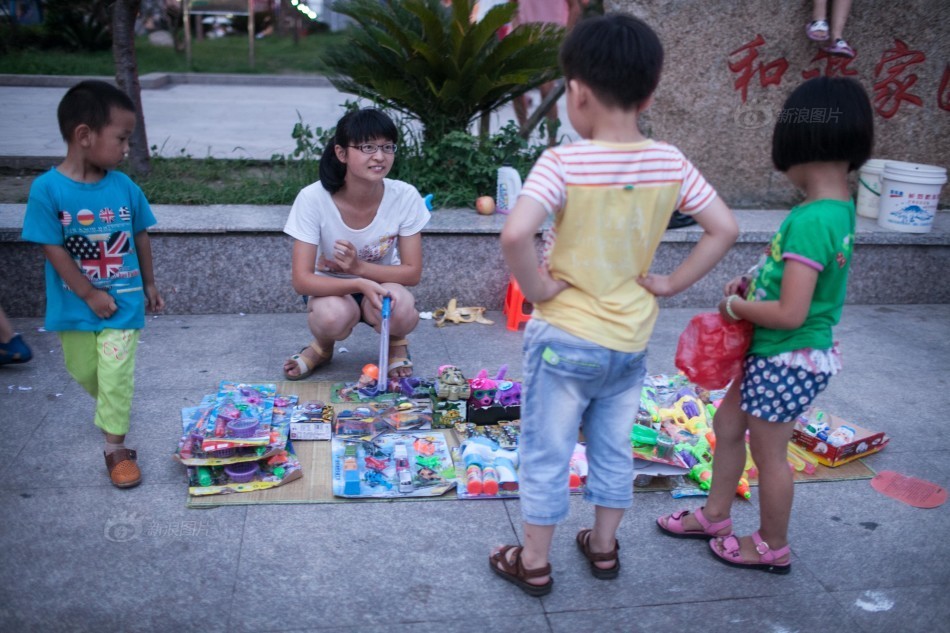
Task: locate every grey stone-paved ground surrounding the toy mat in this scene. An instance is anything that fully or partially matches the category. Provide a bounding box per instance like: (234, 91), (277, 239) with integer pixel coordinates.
(0, 305), (950, 633)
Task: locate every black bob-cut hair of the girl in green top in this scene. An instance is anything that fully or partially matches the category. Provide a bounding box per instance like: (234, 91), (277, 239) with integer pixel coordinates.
(772, 77), (874, 172)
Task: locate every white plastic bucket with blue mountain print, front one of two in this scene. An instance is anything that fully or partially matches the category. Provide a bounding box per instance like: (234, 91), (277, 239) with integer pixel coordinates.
(877, 160), (947, 233)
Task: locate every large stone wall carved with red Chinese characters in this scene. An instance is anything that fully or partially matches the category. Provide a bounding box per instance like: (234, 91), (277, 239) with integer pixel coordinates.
(604, 0), (950, 208)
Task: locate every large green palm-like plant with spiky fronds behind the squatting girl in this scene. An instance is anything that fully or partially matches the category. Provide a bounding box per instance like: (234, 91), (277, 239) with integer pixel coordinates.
(323, 0), (564, 142)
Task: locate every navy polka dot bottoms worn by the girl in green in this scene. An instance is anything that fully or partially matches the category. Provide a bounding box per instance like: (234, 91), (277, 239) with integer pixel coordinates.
(740, 356), (831, 422)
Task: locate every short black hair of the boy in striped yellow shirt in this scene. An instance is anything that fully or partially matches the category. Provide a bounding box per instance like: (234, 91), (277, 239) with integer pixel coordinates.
(560, 13), (663, 110)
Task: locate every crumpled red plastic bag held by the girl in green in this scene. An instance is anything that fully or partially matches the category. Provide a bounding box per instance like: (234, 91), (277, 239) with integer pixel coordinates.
(676, 312), (753, 389)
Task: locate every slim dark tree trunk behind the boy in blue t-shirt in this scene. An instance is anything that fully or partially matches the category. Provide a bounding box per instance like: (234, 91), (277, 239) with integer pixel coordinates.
(112, 0), (152, 176)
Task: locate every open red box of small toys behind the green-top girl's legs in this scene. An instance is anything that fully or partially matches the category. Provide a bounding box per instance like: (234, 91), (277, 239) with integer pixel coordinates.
(792, 408), (891, 468)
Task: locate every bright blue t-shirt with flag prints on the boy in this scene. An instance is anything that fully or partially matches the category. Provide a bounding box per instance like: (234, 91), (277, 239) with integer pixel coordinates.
(21, 168), (155, 332)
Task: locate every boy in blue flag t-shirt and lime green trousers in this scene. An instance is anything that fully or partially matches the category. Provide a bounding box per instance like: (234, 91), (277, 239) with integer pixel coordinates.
(22, 80), (165, 488)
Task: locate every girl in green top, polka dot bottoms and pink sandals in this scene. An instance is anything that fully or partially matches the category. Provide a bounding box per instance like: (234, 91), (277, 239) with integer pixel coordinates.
(657, 77), (874, 574)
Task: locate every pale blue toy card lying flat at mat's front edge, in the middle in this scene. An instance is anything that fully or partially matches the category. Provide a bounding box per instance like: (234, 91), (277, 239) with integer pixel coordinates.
(331, 430), (456, 498)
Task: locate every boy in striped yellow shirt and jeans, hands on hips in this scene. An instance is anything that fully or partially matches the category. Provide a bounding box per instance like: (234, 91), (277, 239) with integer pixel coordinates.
(489, 14), (738, 596)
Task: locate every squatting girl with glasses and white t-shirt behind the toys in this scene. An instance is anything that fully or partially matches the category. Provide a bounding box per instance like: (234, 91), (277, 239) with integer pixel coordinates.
(284, 108), (430, 380)
